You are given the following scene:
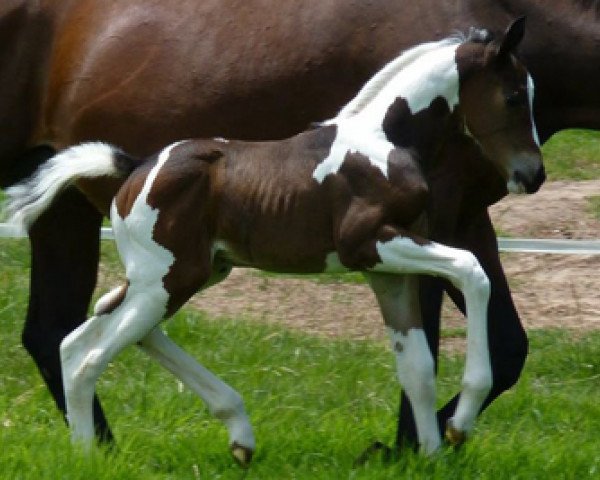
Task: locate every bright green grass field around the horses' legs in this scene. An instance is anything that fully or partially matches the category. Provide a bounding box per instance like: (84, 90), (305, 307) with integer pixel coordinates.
(0, 132), (600, 479)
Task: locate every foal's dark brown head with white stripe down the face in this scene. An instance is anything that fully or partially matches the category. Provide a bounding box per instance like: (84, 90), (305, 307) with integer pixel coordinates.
(456, 18), (546, 193)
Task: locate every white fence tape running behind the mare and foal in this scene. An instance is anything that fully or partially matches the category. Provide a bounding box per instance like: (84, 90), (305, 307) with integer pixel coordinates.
(0, 223), (600, 255)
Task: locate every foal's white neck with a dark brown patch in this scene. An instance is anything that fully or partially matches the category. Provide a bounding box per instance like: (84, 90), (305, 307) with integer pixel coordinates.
(334, 43), (461, 169)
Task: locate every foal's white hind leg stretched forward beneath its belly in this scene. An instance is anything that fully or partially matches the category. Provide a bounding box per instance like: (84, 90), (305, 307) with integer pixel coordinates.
(140, 327), (255, 450)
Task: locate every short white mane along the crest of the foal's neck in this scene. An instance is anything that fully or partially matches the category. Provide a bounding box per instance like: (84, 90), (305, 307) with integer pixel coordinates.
(335, 28), (492, 120)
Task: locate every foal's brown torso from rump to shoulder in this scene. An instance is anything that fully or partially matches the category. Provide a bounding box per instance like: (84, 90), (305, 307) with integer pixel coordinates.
(116, 125), (423, 273)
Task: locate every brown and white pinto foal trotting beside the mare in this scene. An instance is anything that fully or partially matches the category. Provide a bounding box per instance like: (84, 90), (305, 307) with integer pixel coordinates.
(8, 21), (544, 464)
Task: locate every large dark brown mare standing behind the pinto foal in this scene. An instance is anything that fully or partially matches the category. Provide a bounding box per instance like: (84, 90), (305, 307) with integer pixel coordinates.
(0, 0), (600, 450)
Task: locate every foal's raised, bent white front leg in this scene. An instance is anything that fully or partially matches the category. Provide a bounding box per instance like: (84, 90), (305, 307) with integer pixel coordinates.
(374, 237), (492, 438)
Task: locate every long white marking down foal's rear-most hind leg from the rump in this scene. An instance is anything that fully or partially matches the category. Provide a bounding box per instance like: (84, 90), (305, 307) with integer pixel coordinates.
(60, 144), (185, 448)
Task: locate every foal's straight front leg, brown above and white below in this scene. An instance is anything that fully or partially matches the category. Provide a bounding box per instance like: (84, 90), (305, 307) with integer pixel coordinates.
(367, 273), (441, 454)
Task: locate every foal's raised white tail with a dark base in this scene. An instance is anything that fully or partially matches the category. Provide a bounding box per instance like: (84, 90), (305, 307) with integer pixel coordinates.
(5, 143), (140, 230)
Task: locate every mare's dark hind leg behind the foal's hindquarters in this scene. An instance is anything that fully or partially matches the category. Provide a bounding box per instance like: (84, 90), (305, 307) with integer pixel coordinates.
(22, 189), (112, 440)
